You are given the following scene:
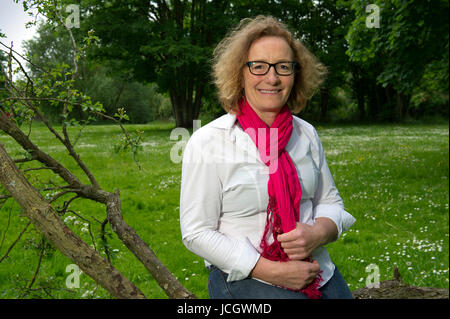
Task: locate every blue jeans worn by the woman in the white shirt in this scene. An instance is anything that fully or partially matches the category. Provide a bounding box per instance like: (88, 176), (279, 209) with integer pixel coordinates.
(208, 266), (353, 299)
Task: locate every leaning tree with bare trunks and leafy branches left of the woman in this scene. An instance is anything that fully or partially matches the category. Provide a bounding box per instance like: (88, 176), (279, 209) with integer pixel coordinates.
(0, 1), (195, 298)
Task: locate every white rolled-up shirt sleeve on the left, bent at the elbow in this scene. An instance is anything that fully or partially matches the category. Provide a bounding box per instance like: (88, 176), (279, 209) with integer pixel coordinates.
(180, 131), (260, 281)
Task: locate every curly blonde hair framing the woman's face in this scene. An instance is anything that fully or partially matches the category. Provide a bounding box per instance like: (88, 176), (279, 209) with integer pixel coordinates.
(213, 15), (327, 113)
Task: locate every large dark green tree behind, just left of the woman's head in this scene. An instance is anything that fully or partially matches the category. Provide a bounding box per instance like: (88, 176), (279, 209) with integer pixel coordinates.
(79, 0), (234, 127)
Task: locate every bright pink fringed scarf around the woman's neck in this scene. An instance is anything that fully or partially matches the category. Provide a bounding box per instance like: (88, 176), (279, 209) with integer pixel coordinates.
(237, 99), (322, 299)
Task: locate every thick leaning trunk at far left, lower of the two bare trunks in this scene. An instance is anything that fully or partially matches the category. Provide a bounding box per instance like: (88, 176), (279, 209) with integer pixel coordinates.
(0, 143), (145, 299)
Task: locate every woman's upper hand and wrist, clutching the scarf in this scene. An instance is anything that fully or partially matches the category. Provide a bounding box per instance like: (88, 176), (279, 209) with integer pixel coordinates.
(277, 218), (337, 260)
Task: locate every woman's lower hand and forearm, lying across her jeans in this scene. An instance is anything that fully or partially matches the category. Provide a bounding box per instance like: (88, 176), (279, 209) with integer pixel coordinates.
(251, 257), (320, 289)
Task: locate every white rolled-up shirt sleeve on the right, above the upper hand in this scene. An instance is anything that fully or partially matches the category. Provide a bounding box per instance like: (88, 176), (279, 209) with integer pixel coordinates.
(313, 130), (356, 239)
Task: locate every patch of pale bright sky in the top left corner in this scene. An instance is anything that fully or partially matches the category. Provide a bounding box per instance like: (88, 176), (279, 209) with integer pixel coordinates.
(0, 0), (36, 54)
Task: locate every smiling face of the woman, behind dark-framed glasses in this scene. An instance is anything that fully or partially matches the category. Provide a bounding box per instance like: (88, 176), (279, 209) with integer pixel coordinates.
(243, 36), (294, 117)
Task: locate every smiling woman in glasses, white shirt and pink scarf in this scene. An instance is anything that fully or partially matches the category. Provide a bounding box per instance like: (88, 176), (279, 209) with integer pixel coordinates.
(180, 16), (355, 299)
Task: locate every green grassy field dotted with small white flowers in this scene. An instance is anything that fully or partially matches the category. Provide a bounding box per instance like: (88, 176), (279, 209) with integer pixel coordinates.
(0, 124), (449, 298)
